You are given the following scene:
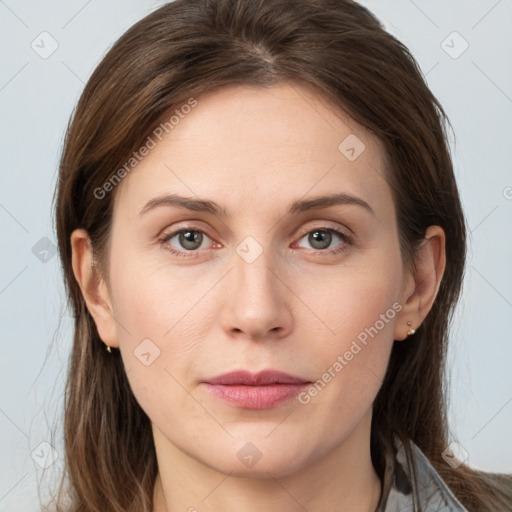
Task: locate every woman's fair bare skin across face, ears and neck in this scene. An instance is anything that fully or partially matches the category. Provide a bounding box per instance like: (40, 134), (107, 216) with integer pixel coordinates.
(71, 83), (445, 512)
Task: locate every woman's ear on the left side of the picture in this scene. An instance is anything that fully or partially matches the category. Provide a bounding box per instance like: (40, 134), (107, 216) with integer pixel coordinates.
(71, 229), (119, 347)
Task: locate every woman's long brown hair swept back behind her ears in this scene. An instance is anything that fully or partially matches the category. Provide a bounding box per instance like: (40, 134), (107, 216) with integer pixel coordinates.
(55, 0), (512, 512)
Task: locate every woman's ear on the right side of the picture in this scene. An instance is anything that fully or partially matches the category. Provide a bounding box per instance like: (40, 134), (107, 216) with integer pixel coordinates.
(395, 226), (446, 340)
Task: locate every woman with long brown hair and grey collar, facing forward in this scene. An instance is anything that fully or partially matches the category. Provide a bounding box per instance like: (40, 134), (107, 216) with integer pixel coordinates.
(51, 0), (512, 512)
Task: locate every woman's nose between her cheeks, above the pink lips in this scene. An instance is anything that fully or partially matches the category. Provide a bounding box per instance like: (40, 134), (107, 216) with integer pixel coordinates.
(221, 245), (293, 341)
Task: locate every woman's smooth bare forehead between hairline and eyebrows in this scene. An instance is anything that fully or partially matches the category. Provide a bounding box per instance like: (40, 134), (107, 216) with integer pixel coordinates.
(116, 83), (391, 220)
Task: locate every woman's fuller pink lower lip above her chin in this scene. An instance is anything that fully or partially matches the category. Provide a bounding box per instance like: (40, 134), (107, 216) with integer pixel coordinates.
(205, 383), (309, 409)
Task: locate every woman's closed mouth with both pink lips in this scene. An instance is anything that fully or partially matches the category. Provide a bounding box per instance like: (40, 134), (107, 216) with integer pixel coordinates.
(203, 370), (311, 409)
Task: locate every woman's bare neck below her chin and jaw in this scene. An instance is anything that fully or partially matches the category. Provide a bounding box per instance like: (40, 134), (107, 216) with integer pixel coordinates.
(153, 415), (381, 512)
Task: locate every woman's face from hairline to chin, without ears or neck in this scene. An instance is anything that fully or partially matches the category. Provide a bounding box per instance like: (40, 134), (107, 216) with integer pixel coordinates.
(98, 83), (411, 476)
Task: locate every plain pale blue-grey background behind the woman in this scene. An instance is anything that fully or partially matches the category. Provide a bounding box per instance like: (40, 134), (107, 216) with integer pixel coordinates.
(0, 0), (512, 512)
